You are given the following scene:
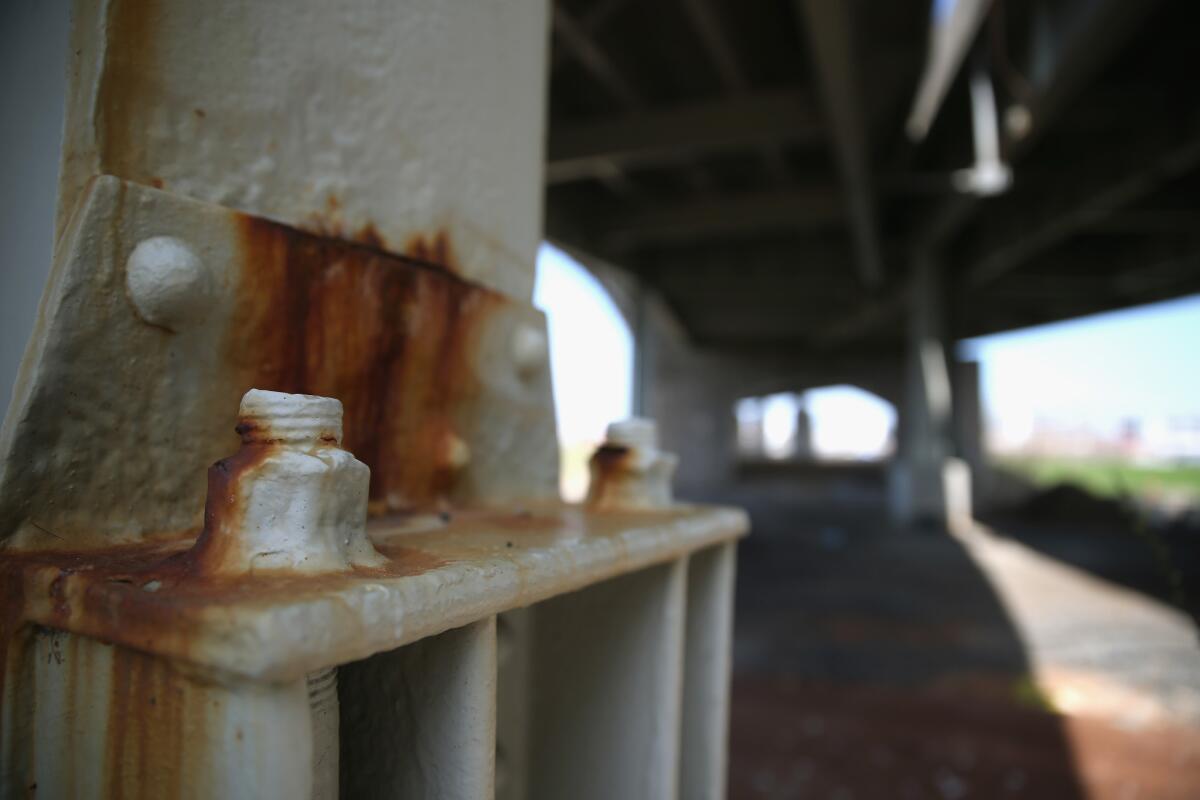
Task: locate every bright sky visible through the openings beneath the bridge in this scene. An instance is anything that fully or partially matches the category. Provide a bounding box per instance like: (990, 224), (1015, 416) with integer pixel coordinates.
(534, 245), (1200, 457)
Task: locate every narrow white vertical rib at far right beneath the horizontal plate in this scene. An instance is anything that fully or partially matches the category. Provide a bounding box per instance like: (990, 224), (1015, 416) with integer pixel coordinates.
(679, 543), (737, 800)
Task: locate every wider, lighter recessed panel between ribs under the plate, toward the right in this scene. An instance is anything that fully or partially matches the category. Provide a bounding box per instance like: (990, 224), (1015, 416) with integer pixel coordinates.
(529, 559), (688, 800)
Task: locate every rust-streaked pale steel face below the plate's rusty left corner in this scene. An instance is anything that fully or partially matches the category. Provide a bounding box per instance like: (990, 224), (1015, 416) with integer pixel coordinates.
(0, 628), (313, 800)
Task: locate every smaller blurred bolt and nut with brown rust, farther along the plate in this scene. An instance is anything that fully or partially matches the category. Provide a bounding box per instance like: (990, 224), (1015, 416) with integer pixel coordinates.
(587, 417), (678, 511)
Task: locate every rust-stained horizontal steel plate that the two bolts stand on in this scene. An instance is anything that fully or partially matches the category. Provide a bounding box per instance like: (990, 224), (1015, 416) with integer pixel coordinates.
(0, 505), (749, 680)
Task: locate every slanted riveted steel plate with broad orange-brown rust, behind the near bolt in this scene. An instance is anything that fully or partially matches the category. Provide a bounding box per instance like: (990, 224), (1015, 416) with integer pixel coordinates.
(0, 176), (557, 549)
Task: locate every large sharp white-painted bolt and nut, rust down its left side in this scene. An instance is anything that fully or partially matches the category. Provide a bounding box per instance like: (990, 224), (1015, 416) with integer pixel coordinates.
(188, 389), (385, 576)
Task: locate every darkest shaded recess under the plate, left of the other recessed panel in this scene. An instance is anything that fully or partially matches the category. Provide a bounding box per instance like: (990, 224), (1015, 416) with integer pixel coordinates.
(338, 616), (496, 800)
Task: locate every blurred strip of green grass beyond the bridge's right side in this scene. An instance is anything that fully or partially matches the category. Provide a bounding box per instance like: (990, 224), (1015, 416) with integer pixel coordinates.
(1000, 457), (1200, 500)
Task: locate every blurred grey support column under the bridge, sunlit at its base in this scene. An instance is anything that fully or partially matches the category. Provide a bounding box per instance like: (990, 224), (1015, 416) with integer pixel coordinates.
(888, 252), (971, 528)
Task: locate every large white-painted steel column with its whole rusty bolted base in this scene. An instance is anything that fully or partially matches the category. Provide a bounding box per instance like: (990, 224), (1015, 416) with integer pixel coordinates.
(0, 0), (748, 800)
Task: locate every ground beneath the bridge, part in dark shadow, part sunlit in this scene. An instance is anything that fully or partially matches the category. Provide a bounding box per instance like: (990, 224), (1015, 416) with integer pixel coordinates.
(730, 484), (1200, 800)
